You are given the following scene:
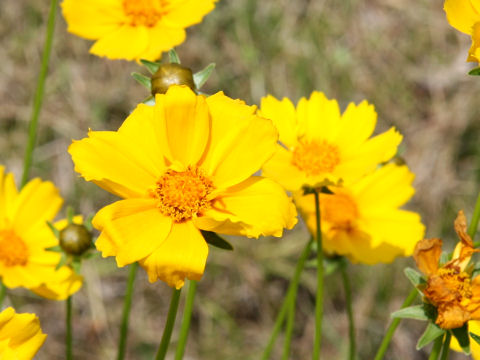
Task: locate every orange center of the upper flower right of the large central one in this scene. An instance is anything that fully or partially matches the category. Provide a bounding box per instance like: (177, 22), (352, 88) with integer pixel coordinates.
(292, 140), (340, 175)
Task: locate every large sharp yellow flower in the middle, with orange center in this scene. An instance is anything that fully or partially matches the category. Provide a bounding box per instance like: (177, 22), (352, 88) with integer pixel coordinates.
(69, 86), (296, 288)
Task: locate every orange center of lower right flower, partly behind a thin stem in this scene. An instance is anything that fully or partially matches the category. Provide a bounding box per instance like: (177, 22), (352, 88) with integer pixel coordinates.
(320, 193), (358, 231)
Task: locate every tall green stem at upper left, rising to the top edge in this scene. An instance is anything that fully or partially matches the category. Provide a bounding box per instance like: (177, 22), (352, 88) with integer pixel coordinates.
(21, 0), (59, 187)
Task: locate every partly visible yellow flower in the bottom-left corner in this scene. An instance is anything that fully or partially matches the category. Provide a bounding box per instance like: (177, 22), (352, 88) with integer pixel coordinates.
(0, 308), (47, 360)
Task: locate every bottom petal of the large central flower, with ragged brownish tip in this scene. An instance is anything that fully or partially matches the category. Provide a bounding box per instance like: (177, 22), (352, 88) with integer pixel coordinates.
(140, 221), (208, 289)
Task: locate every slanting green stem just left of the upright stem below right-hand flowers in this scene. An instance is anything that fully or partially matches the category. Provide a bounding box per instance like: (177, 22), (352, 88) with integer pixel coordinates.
(262, 239), (313, 360)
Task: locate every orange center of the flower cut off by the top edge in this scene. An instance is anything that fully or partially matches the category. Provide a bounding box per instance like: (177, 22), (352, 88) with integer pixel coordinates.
(123, 0), (167, 27)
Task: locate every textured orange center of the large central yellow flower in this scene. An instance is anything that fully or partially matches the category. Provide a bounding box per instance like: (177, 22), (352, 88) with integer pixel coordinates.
(150, 166), (214, 222)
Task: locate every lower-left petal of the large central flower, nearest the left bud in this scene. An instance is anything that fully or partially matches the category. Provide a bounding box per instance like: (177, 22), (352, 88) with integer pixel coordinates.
(92, 199), (172, 266)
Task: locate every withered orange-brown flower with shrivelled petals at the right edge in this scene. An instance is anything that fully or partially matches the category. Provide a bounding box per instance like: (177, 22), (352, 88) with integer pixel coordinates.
(413, 211), (480, 329)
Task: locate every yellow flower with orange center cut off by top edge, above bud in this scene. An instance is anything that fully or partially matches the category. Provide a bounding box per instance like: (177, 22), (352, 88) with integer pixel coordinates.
(62, 0), (216, 60)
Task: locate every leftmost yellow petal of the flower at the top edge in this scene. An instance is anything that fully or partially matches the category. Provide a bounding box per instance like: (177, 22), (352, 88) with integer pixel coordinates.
(61, 0), (126, 40)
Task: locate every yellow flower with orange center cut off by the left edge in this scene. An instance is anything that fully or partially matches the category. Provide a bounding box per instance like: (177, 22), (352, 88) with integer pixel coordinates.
(0, 166), (82, 300)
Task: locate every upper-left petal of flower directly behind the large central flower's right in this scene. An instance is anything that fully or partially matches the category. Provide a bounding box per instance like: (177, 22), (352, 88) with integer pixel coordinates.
(259, 95), (297, 148)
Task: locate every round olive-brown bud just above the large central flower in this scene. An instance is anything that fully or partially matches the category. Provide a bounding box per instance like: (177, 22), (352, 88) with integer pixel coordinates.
(152, 63), (195, 96)
